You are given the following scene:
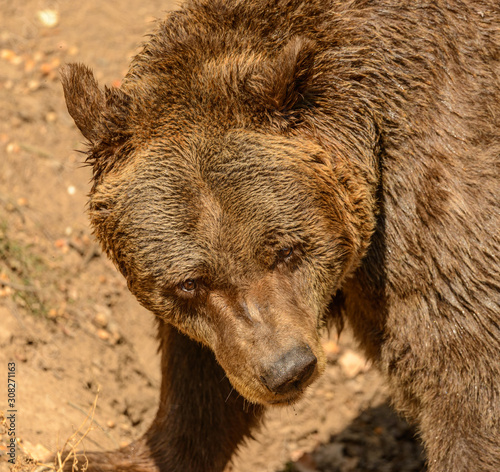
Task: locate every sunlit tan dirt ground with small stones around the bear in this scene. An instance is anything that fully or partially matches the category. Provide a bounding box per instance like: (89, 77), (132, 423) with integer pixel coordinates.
(0, 0), (424, 472)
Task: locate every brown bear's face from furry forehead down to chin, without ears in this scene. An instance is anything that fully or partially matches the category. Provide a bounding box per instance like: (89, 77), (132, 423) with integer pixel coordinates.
(85, 123), (368, 404)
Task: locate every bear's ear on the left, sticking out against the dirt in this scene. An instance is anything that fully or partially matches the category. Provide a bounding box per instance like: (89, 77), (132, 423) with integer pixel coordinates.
(61, 64), (128, 146)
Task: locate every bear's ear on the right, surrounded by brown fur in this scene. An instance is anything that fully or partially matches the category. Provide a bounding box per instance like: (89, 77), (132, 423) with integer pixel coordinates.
(252, 36), (316, 112)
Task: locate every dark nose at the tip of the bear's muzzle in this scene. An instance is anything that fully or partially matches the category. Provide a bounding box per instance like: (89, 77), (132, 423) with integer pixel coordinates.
(261, 346), (318, 394)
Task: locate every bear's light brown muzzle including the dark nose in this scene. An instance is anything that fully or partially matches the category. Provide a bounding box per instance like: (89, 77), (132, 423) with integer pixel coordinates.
(208, 284), (325, 405)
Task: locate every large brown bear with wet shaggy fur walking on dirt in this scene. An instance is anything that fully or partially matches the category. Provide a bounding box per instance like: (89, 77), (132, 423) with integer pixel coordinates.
(62, 0), (500, 472)
